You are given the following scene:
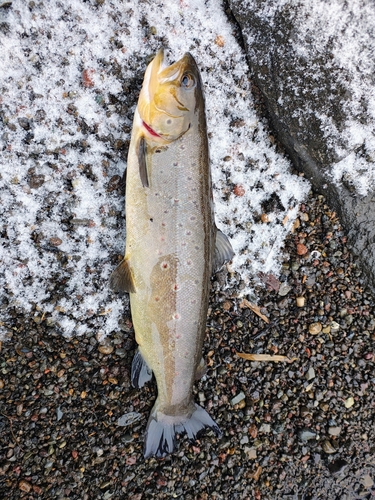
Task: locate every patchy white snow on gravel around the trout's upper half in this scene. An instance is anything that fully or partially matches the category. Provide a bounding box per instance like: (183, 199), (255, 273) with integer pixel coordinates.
(0, 0), (309, 337)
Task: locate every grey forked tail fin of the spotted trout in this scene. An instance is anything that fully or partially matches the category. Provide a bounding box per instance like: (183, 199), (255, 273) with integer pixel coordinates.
(144, 403), (222, 458)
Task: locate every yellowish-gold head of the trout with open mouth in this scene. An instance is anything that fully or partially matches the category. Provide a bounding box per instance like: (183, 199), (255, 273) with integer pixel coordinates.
(138, 49), (203, 142)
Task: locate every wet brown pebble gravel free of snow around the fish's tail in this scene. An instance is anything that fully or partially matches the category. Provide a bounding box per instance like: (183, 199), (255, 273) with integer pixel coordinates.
(0, 189), (375, 500)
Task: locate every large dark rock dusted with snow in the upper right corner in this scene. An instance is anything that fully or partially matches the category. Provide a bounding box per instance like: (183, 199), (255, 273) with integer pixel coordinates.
(229, 0), (375, 287)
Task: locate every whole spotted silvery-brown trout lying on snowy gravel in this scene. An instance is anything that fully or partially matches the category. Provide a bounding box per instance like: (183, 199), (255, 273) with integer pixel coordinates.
(110, 49), (234, 457)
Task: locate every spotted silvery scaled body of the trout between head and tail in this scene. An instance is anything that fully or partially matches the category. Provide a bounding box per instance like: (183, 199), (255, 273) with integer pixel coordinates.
(126, 110), (213, 406)
